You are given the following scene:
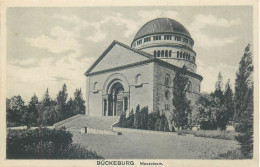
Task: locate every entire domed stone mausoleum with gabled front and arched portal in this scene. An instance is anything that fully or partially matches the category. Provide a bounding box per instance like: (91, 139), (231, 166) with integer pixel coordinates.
(85, 18), (202, 117)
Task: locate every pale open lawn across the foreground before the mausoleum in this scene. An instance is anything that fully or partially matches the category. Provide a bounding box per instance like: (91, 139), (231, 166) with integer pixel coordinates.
(70, 132), (239, 159)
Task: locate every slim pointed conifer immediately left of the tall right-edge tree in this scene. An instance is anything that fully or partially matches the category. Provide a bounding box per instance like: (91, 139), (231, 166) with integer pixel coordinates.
(224, 79), (235, 120)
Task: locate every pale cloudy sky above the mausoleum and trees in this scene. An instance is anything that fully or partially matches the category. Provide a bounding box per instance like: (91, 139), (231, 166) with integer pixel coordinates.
(6, 6), (253, 102)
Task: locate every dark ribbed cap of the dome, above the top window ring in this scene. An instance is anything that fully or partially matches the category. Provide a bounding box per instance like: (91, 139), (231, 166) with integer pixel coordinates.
(134, 18), (191, 40)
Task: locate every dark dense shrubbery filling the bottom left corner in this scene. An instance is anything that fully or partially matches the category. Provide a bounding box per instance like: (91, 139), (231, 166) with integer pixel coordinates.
(6, 128), (101, 159)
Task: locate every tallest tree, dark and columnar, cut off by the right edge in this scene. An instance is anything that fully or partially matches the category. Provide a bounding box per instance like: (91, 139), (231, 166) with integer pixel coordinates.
(235, 44), (254, 158)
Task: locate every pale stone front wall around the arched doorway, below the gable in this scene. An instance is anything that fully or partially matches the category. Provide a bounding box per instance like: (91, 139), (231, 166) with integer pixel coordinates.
(86, 59), (153, 116)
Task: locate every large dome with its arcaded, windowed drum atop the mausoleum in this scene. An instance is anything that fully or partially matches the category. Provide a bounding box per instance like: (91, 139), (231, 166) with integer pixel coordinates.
(131, 18), (197, 73)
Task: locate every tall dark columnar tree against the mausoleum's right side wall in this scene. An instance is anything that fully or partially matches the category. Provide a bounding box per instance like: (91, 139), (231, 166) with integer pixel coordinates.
(173, 68), (191, 129)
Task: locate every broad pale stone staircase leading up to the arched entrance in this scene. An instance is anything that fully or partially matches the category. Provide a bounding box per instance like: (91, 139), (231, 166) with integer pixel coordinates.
(54, 115), (119, 131)
